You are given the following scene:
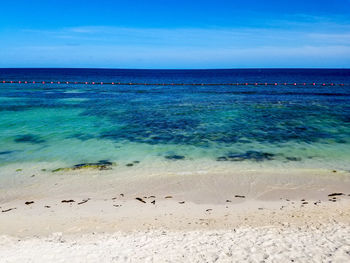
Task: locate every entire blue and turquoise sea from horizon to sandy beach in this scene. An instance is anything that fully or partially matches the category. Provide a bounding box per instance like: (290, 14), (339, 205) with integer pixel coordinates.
(0, 69), (350, 173)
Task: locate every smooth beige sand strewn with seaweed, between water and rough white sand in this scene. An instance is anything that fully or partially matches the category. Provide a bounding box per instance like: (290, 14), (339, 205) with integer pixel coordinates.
(0, 166), (350, 236)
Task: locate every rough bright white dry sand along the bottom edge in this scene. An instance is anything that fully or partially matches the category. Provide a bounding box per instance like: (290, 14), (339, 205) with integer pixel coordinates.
(0, 224), (350, 262)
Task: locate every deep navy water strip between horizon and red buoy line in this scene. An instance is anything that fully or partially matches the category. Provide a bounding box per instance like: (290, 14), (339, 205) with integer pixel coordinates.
(0, 69), (350, 83)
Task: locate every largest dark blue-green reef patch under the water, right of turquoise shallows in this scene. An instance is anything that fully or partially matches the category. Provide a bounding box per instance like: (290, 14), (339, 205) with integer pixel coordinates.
(93, 98), (350, 147)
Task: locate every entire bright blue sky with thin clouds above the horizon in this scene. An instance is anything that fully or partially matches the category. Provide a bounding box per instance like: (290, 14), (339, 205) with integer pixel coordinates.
(0, 0), (350, 69)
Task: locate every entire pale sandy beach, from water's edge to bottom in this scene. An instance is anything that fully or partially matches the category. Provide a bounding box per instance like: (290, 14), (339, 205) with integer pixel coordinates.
(0, 166), (350, 262)
